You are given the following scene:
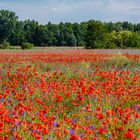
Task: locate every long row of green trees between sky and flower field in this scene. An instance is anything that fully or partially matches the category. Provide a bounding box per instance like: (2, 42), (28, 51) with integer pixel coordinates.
(0, 10), (140, 48)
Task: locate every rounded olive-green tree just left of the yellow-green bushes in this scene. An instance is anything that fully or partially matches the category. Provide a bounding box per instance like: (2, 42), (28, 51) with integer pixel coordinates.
(86, 21), (107, 49)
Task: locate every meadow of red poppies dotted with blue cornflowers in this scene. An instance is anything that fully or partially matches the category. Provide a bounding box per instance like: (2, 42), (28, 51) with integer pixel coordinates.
(0, 50), (140, 140)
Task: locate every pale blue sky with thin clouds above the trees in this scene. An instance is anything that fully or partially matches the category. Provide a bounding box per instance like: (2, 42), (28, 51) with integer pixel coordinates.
(0, 0), (140, 24)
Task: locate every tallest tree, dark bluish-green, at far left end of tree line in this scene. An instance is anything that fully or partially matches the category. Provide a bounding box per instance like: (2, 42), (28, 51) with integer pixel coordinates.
(0, 10), (18, 43)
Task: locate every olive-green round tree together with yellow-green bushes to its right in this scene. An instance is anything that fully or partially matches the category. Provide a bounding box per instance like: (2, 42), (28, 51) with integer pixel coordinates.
(86, 21), (140, 49)
